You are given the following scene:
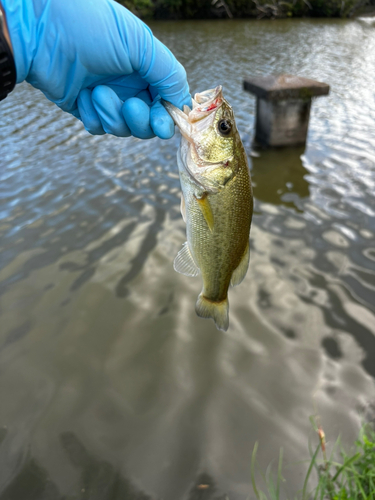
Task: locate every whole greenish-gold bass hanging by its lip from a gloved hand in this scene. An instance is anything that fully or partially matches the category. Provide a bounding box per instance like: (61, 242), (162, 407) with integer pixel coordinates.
(163, 86), (253, 331)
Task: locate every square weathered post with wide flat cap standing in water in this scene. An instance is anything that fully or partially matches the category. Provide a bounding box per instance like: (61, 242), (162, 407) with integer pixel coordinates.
(244, 75), (329, 147)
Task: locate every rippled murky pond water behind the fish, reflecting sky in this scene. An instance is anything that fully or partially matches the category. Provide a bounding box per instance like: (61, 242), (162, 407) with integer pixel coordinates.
(0, 16), (375, 500)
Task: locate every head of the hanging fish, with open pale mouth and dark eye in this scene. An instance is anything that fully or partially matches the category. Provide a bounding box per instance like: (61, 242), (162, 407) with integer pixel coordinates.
(163, 86), (237, 191)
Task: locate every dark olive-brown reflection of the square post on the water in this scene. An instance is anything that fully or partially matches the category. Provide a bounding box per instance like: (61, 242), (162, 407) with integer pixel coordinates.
(251, 147), (310, 211)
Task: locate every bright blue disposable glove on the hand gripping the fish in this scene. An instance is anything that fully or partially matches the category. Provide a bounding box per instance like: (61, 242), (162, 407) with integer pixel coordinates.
(0, 0), (191, 139)
